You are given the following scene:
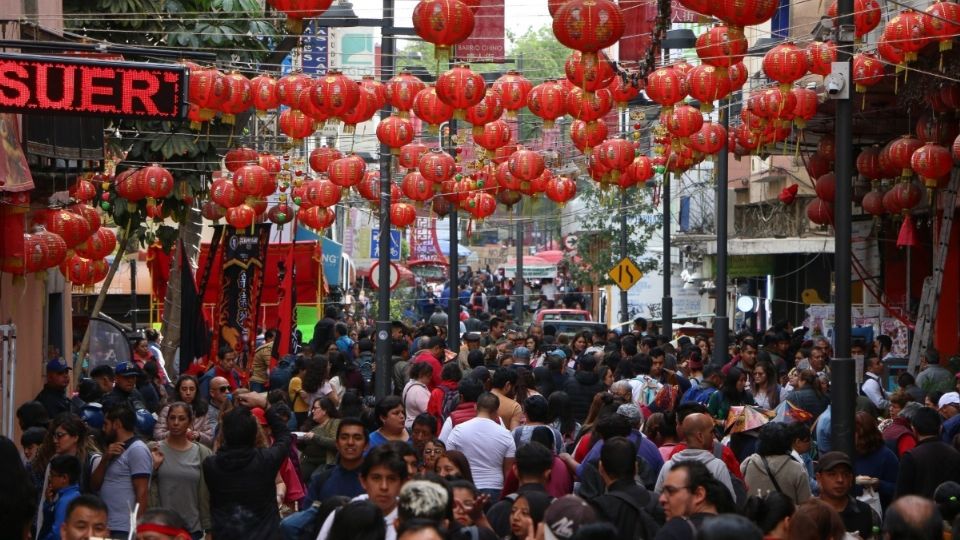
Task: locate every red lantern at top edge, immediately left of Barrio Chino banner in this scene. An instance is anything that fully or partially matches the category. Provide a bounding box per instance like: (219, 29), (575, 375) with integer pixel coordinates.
(413, 0), (474, 63)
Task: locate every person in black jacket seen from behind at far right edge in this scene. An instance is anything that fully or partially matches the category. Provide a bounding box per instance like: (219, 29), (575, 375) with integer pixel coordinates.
(896, 407), (960, 499)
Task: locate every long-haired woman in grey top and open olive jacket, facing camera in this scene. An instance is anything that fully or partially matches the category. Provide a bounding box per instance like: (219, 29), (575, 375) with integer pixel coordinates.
(150, 401), (213, 538)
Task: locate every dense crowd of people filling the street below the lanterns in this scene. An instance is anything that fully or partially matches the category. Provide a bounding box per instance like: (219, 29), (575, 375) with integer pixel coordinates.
(0, 298), (960, 540)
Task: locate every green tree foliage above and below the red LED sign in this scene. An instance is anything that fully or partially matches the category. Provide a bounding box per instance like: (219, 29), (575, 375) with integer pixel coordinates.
(63, 0), (278, 248)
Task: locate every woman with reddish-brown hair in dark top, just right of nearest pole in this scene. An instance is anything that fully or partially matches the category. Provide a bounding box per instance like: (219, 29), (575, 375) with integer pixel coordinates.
(853, 411), (900, 508)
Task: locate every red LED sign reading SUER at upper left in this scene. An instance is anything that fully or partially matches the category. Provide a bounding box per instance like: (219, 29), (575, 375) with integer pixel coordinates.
(0, 54), (188, 120)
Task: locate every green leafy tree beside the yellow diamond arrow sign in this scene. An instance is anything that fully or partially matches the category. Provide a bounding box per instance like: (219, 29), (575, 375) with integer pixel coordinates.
(566, 181), (660, 292)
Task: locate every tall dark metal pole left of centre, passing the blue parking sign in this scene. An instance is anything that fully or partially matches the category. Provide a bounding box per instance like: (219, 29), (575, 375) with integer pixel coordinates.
(374, 0), (396, 399)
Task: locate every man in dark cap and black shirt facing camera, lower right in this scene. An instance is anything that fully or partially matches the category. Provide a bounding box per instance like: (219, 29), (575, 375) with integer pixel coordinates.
(817, 452), (880, 538)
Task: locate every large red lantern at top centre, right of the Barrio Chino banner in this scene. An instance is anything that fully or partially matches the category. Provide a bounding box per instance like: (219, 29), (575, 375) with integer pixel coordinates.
(553, 0), (624, 53)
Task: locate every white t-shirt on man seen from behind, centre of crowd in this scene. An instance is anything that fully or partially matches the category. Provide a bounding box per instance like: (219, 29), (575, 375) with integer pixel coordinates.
(446, 418), (517, 489)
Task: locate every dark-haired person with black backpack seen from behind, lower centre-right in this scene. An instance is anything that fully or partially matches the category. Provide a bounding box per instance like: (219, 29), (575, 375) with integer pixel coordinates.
(591, 437), (664, 540)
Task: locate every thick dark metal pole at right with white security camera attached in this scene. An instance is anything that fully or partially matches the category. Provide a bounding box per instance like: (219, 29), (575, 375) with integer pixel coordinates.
(830, 0), (857, 459)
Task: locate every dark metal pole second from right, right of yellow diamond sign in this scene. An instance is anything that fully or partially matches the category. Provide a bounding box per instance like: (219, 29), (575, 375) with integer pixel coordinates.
(704, 98), (730, 366)
